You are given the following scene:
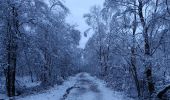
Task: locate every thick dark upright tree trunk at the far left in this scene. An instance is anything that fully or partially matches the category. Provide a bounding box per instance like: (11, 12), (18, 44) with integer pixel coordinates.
(6, 7), (19, 97)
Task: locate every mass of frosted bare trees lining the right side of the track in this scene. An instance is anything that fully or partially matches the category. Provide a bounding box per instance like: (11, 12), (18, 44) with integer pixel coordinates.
(84, 0), (170, 99)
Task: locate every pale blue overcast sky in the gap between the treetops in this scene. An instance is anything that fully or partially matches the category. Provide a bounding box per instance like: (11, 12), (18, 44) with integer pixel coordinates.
(65, 0), (104, 48)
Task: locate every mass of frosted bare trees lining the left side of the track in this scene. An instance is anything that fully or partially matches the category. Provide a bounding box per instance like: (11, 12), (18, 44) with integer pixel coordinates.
(0, 0), (81, 97)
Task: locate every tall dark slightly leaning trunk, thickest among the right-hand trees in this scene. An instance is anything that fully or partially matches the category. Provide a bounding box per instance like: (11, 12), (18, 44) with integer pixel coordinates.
(138, 0), (155, 98)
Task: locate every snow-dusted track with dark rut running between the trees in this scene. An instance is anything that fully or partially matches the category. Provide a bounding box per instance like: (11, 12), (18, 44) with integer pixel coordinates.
(16, 73), (130, 100)
